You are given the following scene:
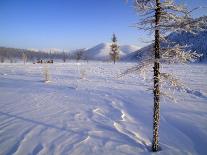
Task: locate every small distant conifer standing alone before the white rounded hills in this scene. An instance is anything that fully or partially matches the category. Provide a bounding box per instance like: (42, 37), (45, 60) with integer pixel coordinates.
(109, 34), (119, 64)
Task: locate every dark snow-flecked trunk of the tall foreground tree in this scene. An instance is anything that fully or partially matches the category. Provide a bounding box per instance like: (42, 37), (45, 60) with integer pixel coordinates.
(152, 0), (161, 152)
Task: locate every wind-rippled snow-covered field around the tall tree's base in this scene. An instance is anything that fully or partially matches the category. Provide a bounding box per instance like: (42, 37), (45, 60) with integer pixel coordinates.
(0, 62), (207, 155)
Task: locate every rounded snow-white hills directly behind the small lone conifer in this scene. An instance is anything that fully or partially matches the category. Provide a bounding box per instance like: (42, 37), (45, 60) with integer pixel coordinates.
(84, 43), (139, 61)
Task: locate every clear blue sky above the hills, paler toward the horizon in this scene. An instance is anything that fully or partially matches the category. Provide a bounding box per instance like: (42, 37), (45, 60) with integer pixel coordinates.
(0, 0), (207, 49)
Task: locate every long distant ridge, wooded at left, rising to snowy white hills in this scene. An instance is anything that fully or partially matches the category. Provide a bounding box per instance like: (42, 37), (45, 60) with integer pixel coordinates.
(0, 43), (139, 62)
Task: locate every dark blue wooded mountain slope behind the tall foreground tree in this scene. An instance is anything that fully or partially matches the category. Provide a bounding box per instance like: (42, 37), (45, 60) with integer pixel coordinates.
(124, 17), (207, 62)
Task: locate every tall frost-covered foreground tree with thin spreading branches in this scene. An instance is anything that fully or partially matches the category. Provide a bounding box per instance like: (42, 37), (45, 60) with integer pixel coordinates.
(127, 0), (206, 152)
